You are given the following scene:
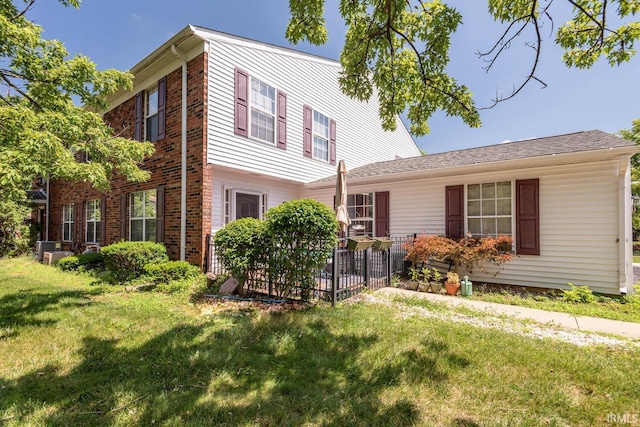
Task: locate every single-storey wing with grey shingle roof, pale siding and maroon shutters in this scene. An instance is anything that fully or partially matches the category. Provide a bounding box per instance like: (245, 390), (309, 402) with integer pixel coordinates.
(302, 130), (639, 294)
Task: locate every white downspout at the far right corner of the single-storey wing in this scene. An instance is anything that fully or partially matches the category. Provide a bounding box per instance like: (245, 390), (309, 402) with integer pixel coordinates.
(618, 155), (633, 295)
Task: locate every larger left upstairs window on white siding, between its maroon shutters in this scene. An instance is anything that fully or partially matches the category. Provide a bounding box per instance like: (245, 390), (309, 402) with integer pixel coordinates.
(251, 77), (276, 144)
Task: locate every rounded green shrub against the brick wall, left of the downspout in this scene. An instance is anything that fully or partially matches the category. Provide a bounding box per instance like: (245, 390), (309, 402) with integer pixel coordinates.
(100, 242), (169, 282)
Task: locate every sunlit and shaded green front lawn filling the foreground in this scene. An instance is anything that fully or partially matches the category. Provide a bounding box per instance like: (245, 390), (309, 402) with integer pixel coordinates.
(0, 259), (640, 427)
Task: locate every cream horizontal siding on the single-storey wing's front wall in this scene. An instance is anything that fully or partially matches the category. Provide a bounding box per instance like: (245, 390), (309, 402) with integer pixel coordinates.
(302, 160), (620, 294)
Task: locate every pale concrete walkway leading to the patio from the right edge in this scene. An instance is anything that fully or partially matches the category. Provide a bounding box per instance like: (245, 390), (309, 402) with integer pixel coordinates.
(375, 288), (640, 339)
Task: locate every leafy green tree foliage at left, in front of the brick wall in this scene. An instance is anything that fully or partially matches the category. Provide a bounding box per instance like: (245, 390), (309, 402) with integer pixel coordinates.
(0, 0), (153, 200)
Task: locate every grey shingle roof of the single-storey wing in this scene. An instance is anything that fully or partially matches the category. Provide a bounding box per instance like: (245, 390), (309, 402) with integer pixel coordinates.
(315, 130), (637, 183)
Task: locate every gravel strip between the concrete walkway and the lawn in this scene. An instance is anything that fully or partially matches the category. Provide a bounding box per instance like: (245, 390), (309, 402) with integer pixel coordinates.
(351, 293), (640, 348)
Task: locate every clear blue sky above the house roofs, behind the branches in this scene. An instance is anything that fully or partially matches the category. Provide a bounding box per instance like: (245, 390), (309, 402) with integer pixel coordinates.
(27, 0), (640, 153)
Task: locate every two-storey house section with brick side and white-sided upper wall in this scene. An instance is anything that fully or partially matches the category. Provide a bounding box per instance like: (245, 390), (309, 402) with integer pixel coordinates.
(49, 26), (420, 264)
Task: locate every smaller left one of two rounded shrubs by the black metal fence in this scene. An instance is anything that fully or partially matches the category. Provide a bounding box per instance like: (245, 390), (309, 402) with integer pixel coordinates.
(213, 218), (269, 289)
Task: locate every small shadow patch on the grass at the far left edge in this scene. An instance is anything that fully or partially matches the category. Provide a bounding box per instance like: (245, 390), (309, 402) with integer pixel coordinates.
(0, 290), (99, 339)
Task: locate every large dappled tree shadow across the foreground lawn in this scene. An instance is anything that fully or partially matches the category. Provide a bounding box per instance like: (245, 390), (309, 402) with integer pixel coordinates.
(0, 313), (469, 425)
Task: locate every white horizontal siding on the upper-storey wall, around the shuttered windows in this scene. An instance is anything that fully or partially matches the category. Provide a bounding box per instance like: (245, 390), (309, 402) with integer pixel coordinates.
(198, 31), (420, 183)
